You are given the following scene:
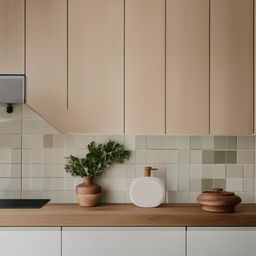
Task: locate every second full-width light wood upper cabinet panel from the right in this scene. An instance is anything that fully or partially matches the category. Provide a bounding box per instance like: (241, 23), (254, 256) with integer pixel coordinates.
(166, 0), (209, 134)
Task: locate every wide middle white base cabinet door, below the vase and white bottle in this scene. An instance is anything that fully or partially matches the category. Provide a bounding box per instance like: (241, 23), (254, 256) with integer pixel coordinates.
(62, 227), (185, 256)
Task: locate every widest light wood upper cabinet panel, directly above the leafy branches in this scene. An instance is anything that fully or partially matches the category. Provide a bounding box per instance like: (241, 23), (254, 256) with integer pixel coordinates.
(67, 0), (124, 134)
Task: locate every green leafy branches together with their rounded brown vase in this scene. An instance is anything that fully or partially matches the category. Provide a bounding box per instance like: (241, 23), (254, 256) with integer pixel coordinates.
(65, 141), (130, 206)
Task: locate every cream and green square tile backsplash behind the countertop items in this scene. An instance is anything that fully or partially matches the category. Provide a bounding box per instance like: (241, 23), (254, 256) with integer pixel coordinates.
(0, 105), (255, 203)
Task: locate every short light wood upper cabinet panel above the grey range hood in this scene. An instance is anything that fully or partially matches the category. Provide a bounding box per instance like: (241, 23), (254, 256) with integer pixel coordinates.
(0, 0), (25, 74)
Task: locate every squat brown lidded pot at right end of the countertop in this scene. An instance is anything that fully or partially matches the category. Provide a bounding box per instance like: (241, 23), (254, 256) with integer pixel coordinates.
(197, 188), (241, 212)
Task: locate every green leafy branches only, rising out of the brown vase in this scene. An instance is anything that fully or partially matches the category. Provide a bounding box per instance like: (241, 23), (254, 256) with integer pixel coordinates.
(65, 140), (130, 177)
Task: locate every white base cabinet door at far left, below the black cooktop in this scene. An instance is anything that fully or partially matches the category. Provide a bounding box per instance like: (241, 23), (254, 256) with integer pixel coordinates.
(0, 227), (61, 256)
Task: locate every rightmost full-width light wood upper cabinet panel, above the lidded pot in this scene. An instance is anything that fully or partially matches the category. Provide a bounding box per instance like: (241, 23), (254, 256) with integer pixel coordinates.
(210, 0), (253, 134)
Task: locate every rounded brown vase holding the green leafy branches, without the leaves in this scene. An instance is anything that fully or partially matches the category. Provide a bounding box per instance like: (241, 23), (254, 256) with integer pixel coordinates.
(76, 177), (101, 207)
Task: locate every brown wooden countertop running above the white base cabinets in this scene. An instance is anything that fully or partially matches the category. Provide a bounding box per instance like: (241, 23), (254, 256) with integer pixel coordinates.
(0, 204), (256, 227)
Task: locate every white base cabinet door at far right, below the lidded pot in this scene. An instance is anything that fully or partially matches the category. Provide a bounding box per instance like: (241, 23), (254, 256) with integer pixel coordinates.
(187, 227), (256, 256)
